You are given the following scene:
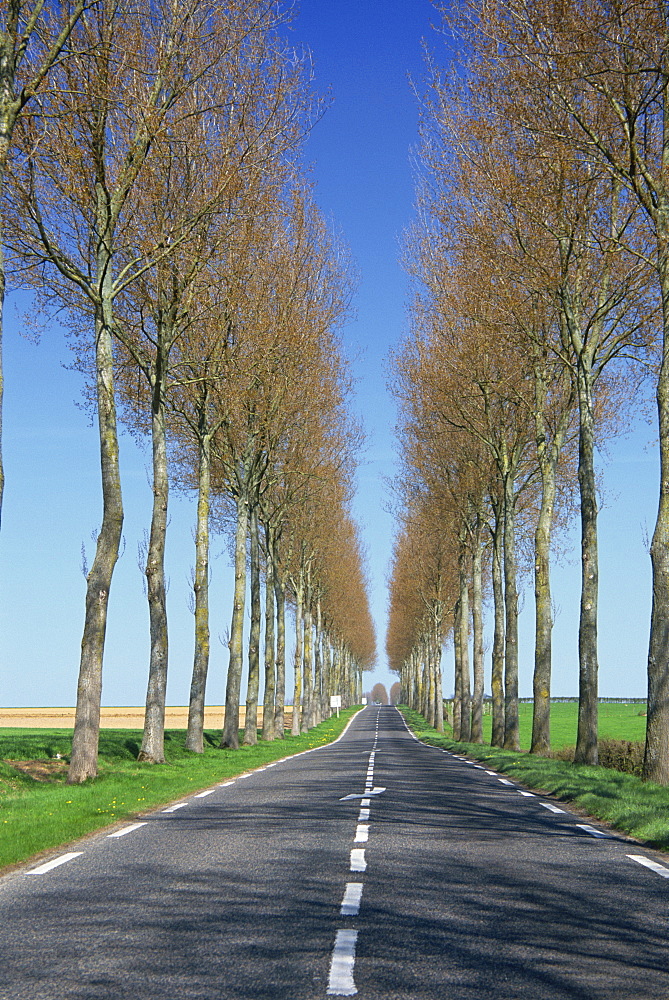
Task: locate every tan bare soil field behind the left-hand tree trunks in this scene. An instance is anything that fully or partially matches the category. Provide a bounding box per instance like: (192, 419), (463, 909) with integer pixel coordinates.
(0, 705), (292, 729)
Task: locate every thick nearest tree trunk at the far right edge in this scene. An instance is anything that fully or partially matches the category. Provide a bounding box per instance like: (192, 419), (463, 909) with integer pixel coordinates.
(643, 240), (669, 785)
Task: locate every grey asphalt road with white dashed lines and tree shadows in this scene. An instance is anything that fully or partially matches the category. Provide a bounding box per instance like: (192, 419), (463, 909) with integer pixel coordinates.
(0, 706), (669, 1000)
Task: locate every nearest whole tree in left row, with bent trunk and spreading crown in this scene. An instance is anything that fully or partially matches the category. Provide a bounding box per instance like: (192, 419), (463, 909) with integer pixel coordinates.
(6, 0), (290, 782)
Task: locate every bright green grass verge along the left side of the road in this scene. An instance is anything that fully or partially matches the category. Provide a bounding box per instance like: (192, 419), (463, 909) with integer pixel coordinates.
(0, 709), (356, 869)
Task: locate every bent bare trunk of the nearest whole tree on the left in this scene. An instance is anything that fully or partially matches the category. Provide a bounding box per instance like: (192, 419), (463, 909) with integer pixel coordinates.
(67, 302), (123, 784)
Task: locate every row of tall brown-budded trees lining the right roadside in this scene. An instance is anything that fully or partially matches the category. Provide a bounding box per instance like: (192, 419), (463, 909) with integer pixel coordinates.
(388, 0), (669, 783)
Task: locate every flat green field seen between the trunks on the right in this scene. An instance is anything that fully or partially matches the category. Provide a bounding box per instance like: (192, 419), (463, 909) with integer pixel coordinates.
(483, 701), (646, 750)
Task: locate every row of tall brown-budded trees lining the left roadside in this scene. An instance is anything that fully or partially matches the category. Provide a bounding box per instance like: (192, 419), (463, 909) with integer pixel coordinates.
(0, 0), (374, 782)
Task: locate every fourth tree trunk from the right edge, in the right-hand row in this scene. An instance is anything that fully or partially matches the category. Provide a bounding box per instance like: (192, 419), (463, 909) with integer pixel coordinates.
(504, 471), (520, 750)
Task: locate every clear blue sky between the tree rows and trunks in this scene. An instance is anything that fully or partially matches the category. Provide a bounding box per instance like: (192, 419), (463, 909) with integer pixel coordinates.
(0, 0), (658, 706)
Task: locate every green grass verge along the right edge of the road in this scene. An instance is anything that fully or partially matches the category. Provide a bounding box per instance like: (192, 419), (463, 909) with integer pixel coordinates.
(401, 706), (669, 851)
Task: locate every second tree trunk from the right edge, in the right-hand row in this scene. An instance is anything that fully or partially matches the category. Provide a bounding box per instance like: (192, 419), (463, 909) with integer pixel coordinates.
(574, 358), (599, 764)
